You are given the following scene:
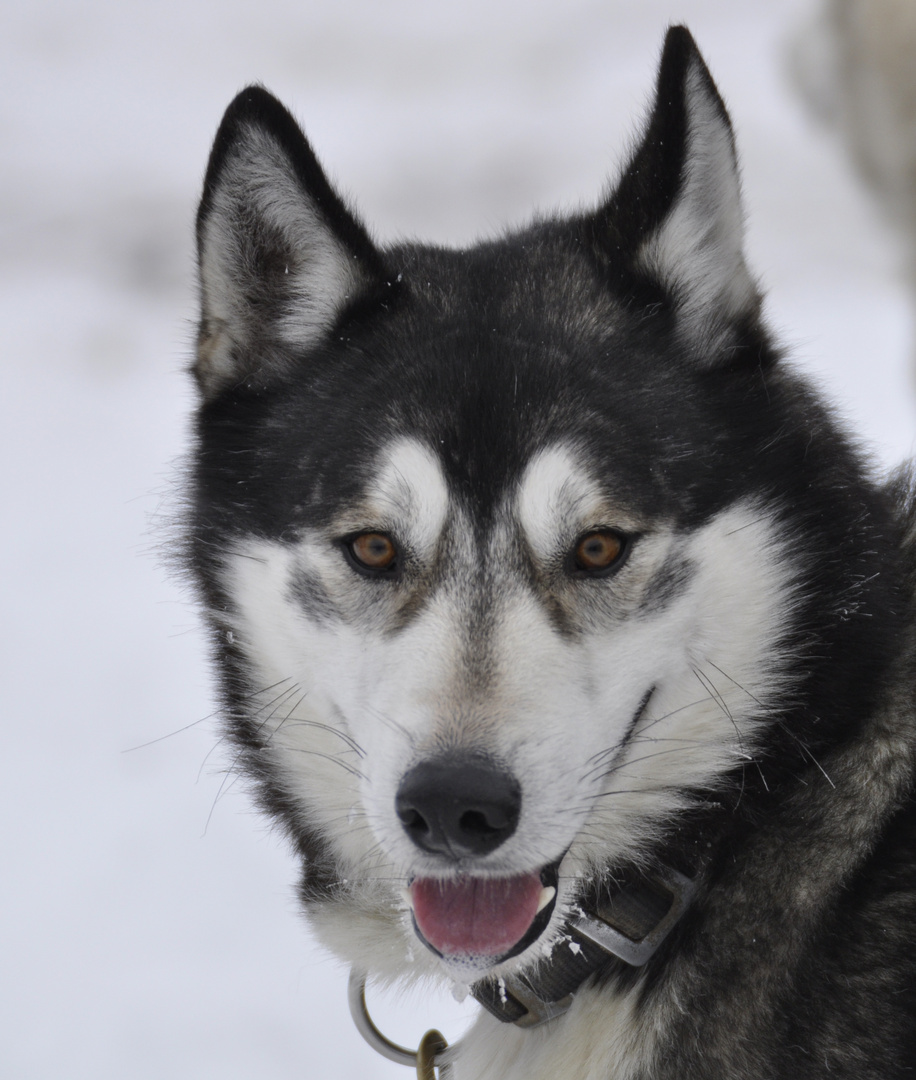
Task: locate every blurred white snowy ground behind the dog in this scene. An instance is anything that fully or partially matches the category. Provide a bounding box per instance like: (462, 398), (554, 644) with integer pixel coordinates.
(0, 0), (916, 1080)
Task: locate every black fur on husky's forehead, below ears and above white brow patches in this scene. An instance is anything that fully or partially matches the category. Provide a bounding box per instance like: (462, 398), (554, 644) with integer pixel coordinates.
(191, 238), (738, 536)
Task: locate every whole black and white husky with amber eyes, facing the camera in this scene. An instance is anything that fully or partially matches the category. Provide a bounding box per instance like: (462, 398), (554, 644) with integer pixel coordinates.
(185, 27), (916, 1080)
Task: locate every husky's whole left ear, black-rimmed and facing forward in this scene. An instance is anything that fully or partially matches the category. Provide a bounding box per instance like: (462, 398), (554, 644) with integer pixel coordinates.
(194, 86), (385, 399)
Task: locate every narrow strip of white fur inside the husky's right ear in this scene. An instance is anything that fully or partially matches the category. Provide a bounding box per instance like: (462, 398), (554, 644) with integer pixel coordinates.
(638, 63), (757, 338)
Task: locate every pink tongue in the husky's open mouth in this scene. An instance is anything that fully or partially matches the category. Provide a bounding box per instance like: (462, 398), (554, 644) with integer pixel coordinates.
(410, 874), (542, 956)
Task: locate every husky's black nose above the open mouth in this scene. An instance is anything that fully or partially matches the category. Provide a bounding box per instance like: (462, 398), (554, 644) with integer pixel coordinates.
(394, 755), (522, 859)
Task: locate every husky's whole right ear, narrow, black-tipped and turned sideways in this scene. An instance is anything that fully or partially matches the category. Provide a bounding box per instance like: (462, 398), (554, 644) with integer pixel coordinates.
(605, 26), (759, 355)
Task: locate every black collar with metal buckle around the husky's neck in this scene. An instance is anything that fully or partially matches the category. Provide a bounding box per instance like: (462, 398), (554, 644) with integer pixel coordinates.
(471, 865), (697, 1027)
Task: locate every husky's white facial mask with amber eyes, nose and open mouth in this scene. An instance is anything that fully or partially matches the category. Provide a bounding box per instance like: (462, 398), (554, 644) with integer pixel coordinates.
(214, 447), (791, 981)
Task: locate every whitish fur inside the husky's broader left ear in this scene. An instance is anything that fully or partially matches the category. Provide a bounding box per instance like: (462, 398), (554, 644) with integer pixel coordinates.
(201, 119), (359, 377)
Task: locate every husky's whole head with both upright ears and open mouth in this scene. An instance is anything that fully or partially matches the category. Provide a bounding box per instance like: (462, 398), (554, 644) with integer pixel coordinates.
(189, 30), (831, 982)
